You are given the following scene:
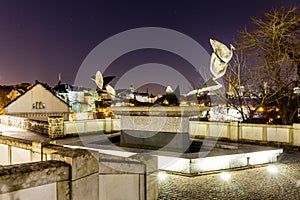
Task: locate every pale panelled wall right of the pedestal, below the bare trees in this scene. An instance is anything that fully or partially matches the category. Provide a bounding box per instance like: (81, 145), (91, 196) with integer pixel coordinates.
(189, 121), (300, 146)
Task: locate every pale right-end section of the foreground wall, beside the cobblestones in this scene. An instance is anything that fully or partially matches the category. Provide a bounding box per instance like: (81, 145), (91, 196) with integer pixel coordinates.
(99, 154), (147, 200)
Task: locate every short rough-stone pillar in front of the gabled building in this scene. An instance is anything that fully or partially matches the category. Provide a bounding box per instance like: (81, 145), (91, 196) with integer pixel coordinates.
(48, 116), (64, 139)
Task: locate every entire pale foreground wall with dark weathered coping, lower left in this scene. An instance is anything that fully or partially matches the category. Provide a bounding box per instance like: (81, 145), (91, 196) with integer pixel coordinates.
(0, 136), (157, 200)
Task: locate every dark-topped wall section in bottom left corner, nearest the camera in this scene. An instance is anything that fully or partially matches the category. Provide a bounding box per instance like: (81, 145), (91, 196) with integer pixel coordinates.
(0, 160), (70, 200)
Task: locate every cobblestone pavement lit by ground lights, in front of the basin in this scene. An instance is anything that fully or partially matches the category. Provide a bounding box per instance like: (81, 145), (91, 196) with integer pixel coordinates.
(159, 151), (300, 200)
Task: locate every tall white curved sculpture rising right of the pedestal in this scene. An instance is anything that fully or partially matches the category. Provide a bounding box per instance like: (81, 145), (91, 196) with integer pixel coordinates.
(187, 39), (235, 96)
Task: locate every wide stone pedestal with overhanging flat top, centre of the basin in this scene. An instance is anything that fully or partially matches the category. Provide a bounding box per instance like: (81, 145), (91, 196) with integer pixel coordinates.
(111, 106), (208, 152)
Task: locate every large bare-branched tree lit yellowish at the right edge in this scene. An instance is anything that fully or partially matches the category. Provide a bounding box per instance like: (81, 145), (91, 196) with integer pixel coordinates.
(231, 7), (300, 124)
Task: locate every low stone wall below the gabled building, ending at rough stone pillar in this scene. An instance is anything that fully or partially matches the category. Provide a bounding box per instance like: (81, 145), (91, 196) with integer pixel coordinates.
(0, 115), (48, 135)
